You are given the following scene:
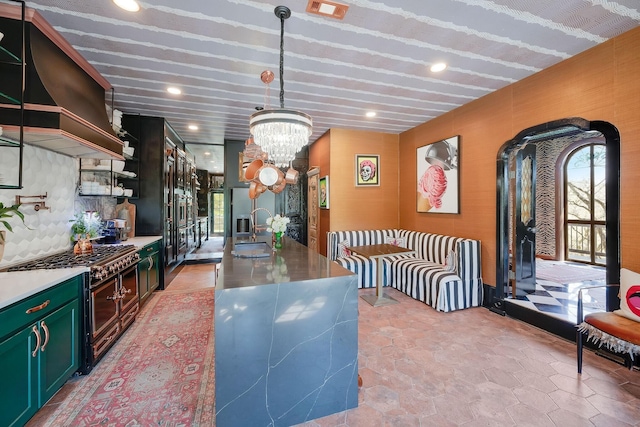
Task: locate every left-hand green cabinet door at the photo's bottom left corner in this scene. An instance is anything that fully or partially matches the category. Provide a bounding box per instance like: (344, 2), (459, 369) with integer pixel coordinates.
(0, 324), (41, 426)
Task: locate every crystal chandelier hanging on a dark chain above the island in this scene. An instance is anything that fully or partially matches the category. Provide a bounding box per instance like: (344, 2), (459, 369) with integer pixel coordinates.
(249, 6), (313, 168)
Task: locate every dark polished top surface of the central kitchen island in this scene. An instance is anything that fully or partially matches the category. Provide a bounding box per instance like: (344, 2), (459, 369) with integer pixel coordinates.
(216, 236), (353, 290)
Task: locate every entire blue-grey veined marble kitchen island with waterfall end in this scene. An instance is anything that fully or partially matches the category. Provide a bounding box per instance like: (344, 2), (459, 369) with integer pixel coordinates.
(214, 237), (358, 427)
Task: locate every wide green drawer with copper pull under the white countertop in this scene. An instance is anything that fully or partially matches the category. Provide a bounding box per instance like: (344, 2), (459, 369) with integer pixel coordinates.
(0, 276), (82, 338)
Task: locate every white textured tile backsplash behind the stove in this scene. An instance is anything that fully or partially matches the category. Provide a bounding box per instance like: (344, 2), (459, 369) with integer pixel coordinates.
(0, 145), (115, 268)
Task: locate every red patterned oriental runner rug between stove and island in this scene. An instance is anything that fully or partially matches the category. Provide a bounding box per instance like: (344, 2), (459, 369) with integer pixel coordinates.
(45, 289), (215, 427)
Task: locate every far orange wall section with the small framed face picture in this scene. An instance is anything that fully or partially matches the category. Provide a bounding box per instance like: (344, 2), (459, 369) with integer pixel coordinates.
(309, 129), (399, 255)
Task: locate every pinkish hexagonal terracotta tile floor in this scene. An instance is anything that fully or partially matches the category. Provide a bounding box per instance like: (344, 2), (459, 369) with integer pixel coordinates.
(28, 264), (640, 427)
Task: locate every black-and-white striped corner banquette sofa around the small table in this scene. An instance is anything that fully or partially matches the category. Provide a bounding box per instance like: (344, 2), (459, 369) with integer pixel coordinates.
(327, 229), (482, 312)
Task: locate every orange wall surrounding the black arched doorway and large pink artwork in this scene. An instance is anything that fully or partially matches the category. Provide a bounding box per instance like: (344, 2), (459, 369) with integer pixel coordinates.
(398, 28), (640, 285)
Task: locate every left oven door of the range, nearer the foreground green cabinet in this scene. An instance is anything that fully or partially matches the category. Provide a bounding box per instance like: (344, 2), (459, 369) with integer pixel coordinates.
(90, 275), (120, 342)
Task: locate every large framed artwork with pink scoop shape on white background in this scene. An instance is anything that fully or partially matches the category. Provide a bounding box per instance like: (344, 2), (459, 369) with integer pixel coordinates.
(416, 136), (460, 214)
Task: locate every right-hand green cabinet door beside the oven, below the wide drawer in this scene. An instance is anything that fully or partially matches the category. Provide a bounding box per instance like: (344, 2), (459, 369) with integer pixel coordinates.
(38, 299), (80, 406)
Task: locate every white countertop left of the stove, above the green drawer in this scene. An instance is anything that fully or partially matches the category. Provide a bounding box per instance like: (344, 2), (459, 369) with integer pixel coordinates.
(0, 267), (89, 309)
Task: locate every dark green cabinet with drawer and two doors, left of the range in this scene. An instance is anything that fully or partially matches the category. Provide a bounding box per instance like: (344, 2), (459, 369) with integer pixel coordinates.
(0, 276), (82, 426)
